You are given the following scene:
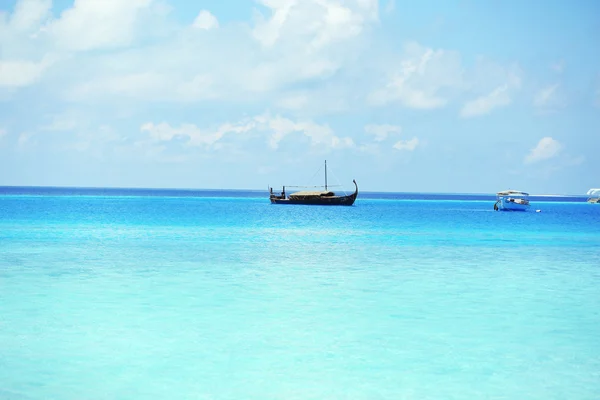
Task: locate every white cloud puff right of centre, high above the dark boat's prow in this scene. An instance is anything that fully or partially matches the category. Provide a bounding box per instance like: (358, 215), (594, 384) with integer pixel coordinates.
(369, 43), (463, 109)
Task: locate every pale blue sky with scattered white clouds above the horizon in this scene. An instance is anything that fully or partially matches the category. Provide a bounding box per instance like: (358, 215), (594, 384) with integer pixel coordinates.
(0, 0), (600, 195)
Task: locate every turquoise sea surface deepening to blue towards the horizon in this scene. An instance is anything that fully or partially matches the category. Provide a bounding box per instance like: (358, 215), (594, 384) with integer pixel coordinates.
(0, 187), (600, 400)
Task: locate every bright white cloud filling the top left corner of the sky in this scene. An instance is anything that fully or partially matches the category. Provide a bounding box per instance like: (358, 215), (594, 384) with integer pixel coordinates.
(0, 0), (159, 88)
